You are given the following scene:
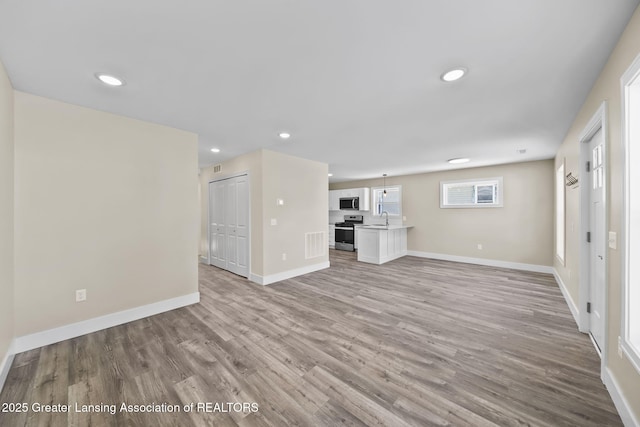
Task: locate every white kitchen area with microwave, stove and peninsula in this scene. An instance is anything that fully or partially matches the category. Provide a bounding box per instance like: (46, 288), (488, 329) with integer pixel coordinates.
(328, 187), (412, 264)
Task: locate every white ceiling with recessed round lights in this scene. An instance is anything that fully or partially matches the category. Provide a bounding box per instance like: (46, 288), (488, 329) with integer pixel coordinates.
(0, 0), (639, 181)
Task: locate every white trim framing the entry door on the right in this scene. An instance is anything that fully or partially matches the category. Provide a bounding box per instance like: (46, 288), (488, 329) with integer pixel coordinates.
(578, 100), (609, 381)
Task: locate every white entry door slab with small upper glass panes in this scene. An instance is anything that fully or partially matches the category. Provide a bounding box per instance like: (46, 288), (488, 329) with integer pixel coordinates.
(589, 128), (606, 349)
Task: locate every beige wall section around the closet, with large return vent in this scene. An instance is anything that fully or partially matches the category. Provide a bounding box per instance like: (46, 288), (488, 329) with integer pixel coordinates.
(200, 150), (329, 282)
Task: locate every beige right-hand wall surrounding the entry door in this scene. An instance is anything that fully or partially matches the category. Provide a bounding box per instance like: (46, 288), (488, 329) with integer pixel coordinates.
(554, 2), (640, 420)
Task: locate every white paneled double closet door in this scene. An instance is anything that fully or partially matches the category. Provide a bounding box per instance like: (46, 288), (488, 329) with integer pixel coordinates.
(209, 175), (249, 277)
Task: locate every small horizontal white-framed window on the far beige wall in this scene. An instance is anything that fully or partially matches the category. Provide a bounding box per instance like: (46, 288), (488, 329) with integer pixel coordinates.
(440, 177), (502, 208)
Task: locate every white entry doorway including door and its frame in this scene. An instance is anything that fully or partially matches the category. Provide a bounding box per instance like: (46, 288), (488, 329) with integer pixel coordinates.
(580, 102), (607, 366)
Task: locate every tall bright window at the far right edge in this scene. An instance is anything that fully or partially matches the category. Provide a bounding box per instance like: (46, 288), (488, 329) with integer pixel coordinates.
(621, 52), (640, 372)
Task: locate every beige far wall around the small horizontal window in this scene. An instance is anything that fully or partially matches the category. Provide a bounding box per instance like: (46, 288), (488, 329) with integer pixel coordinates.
(331, 160), (554, 267)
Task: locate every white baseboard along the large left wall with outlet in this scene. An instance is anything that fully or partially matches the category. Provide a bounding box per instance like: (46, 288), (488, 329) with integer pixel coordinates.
(14, 292), (200, 353)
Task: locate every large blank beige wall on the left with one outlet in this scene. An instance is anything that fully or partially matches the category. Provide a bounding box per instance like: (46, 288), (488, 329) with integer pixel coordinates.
(14, 92), (198, 336)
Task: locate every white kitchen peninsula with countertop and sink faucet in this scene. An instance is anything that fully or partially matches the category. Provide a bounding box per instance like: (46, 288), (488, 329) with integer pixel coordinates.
(356, 225), (413, 264)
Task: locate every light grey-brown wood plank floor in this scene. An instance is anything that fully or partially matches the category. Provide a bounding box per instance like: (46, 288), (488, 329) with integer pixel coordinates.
(0, 251), (622, 427)
